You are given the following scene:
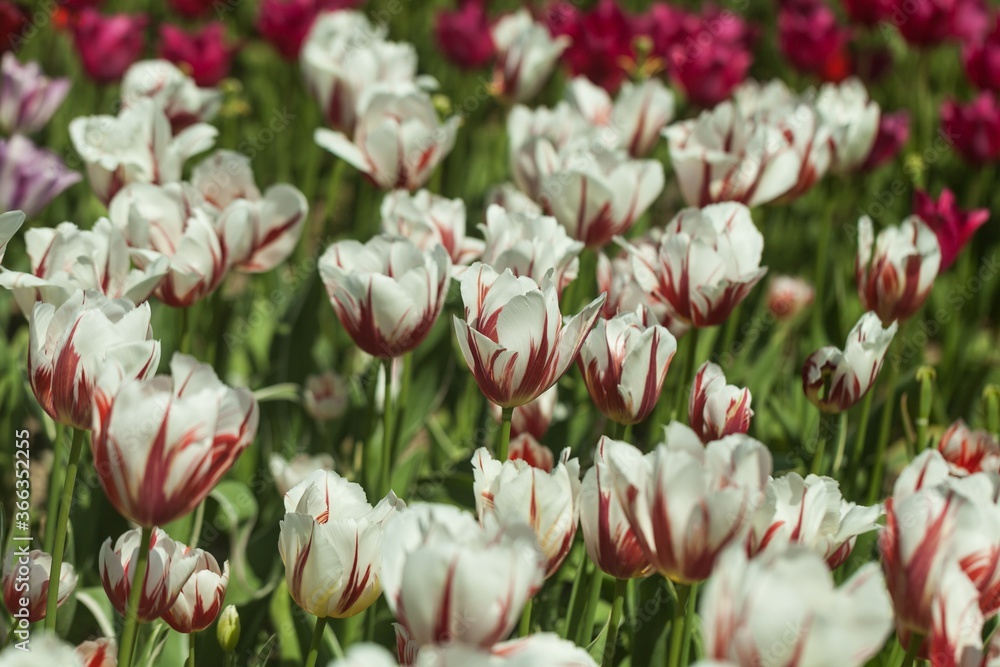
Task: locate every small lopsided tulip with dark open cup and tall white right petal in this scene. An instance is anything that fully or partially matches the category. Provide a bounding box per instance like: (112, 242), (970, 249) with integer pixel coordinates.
(802, 312), (897, 413)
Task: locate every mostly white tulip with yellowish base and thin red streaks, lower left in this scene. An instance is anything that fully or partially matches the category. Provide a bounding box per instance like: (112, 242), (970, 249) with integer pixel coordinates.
(278, 470), (405, 618)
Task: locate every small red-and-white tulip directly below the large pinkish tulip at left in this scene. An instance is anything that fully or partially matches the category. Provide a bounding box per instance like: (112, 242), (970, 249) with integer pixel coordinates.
(100, 528), (198, 622)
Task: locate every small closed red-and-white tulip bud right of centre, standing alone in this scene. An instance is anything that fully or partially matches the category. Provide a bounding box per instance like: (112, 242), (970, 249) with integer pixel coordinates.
(688, 361), (753, 443)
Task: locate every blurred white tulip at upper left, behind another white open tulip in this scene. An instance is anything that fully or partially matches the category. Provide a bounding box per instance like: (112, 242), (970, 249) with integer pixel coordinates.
(121, 60), (222, 135)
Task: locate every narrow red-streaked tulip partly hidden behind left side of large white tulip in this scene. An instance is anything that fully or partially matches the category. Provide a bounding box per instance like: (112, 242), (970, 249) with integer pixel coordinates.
(579, 436), (652, 579)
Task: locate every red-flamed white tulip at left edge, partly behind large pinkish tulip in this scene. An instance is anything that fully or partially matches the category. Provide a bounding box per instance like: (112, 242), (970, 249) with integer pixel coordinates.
(28, 291), (160, 430)
